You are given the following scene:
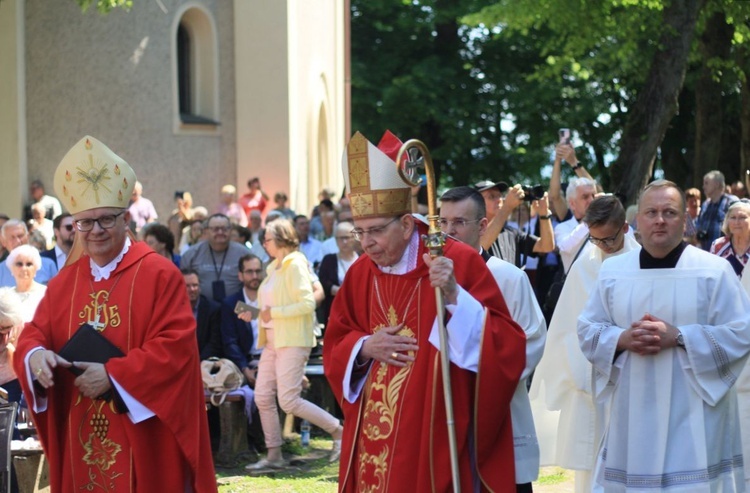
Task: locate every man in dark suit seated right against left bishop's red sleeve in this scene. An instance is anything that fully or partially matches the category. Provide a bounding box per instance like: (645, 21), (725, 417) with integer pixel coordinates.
(181, 269), (223, 360)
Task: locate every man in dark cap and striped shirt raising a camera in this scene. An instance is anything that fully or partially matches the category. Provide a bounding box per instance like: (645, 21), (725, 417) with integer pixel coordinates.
(474, 180), (555, 267)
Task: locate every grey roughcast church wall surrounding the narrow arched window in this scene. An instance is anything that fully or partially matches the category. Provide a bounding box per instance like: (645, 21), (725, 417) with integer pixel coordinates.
(25, 0), (237, 221)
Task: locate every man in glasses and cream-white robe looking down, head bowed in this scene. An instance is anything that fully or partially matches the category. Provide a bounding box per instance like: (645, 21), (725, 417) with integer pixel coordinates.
(529, 195), (640, 493)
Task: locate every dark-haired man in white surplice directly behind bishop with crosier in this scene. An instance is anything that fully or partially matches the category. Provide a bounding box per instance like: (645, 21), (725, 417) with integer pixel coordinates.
(440, 187), (549, 493)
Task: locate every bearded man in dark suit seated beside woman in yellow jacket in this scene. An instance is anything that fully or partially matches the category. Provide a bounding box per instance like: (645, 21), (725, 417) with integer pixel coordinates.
(221, 253), (263, 387)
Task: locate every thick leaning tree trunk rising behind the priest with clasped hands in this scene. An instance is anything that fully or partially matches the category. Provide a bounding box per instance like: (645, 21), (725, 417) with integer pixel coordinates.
(611, 0), (704, 204)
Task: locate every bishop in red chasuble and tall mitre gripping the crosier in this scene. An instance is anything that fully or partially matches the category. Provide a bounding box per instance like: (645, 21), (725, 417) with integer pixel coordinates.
(323, 133), (525, 492)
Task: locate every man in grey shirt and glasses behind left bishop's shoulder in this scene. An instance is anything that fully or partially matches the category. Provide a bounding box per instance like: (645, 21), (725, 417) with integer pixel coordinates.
(180, 213), (250, 303)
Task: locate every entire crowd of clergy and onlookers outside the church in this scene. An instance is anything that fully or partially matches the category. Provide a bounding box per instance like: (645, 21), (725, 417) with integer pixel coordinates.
(0, 129), (750, 492)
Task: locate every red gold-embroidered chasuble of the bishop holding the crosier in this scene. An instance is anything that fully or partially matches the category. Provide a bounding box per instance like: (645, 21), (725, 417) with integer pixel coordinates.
(323, 232), (526, 493)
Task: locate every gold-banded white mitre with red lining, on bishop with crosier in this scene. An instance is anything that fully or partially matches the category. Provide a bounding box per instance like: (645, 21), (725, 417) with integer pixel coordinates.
(342, 132), (411, 219)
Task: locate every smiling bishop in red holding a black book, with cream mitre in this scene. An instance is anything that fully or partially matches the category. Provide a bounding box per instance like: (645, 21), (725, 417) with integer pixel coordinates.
(13, 136), (216, 492)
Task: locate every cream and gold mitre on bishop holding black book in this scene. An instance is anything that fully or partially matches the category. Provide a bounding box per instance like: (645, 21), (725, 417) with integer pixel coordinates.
(55, 135), (136, 214)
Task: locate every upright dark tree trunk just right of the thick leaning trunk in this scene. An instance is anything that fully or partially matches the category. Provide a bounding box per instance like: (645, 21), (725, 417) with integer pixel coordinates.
(693, 12), (733, 184)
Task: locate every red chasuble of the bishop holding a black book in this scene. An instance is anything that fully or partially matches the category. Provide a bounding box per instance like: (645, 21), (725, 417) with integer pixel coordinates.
(14, 243), (217, 493)
